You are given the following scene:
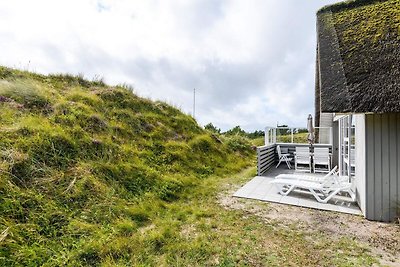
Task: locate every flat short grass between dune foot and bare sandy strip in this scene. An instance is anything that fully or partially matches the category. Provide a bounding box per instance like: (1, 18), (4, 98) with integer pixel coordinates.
(50, 169), (376, 266)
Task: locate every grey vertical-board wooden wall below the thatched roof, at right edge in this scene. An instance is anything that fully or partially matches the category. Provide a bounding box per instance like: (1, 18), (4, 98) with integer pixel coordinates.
(365, 113), (400, 221)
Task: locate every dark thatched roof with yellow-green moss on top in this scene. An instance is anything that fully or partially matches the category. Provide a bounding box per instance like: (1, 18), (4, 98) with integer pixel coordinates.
(316, 0), (400, 113)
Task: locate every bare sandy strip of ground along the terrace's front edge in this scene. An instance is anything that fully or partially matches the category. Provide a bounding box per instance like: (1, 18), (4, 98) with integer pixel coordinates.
(218, 185), (400, 266)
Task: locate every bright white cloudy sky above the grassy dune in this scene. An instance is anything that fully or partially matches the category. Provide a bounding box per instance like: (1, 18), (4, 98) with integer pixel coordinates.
(0, 0), (339, 131)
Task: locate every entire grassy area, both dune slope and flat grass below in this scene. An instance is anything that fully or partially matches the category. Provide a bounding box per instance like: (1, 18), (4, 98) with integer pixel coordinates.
(0, 68), (382, 266)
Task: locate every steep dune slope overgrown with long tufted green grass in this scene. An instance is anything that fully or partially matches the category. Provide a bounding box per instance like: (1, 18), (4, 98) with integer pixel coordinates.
(0, 67), (251, 266)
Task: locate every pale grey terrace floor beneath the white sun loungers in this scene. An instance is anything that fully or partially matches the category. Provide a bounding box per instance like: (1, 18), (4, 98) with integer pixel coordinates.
(233, 168), (362, 215)
